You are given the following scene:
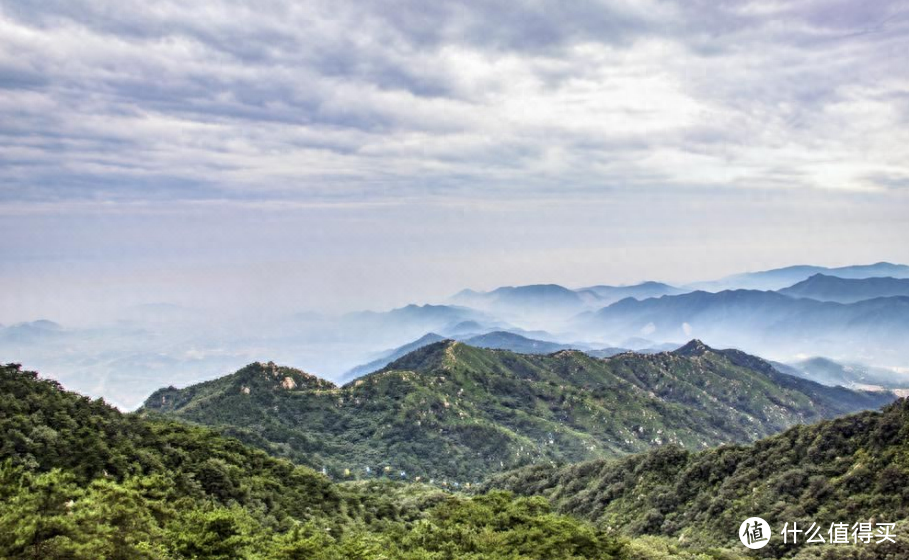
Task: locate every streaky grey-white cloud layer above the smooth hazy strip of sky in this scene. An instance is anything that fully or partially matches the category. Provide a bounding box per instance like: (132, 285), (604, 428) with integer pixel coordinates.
(0, 0), (909, 203)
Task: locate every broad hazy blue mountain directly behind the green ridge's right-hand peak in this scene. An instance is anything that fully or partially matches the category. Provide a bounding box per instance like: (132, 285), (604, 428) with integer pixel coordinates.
(574, 290), (909, 363)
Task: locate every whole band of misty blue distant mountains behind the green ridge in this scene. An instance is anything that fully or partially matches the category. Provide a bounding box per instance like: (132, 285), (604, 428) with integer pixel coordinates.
(7, 263), (909, 410)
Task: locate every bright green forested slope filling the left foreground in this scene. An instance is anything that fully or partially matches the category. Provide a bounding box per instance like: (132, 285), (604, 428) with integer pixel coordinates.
(0, 366), (640, 560)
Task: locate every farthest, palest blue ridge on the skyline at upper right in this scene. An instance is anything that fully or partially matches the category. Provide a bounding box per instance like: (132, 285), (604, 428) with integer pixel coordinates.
(688, 262), (909, 292)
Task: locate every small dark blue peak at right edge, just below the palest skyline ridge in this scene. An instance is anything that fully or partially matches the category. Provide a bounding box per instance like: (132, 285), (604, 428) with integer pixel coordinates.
(779, 274), (909, 303)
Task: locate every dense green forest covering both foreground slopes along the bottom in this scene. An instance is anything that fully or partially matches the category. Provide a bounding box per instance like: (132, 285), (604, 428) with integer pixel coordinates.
(0, 356), (909, 560)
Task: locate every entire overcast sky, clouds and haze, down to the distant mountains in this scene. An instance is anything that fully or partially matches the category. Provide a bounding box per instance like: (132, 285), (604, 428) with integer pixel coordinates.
(0, 0), (909, 323)
